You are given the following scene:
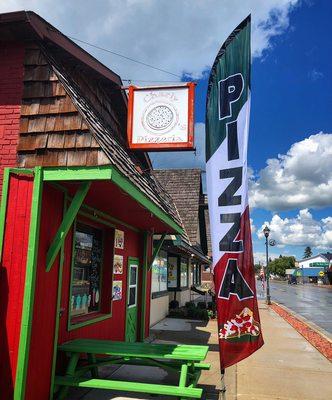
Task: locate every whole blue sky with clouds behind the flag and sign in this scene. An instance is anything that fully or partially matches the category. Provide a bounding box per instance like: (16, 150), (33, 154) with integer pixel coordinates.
(0, 0), (332, 262)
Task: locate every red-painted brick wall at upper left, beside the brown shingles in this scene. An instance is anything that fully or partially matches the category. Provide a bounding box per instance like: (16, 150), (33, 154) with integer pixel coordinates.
(0, 43), (24, 196)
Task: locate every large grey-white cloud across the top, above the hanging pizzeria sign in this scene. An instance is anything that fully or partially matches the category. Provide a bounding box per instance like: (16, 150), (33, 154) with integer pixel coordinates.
(0, 0), (300, 80)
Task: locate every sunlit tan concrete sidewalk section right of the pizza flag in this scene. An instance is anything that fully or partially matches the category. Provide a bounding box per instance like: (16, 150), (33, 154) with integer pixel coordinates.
(233, 303), (332, 400)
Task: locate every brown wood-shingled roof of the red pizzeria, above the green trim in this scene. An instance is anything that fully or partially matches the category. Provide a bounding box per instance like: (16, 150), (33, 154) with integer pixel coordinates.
(0, 11), (182, 230)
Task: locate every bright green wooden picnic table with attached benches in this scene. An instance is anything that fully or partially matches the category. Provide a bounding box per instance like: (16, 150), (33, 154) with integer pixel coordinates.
(55, 339), (210, 400)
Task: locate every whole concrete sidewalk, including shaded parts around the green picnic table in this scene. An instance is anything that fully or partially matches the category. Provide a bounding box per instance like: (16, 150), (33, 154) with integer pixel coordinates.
(63, 303), (332, 400)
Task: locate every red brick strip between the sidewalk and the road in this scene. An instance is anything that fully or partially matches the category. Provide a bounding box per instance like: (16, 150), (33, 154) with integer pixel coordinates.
(269, 302), (332, 362)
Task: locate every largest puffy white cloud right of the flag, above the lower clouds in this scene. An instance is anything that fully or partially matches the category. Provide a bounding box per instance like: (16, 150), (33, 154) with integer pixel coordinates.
(250, 132), (332, 211)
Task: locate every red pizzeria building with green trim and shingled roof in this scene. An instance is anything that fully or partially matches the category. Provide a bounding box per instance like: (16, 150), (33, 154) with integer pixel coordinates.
(0, 12), (182, 400)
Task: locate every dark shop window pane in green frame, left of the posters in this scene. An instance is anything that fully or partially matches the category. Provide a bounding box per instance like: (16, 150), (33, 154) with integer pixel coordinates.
(70, 223), (103, 323)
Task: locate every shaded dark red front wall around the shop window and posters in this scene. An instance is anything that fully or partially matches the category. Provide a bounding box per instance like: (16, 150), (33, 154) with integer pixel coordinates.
(26, 186), (143, 400)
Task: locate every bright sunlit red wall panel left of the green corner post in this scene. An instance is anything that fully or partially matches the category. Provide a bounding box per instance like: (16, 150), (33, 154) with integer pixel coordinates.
(0, 175), (33, 400)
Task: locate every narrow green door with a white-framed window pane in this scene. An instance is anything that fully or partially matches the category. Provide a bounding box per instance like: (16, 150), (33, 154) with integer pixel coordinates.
(126, 257), (138, 342)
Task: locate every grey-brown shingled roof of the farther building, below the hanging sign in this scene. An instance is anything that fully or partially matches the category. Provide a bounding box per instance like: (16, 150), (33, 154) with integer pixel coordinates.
(153, 168), (202, 245)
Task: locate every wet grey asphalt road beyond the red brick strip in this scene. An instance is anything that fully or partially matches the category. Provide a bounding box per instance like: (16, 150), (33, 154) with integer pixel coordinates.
(257, 281), (332, 334)
